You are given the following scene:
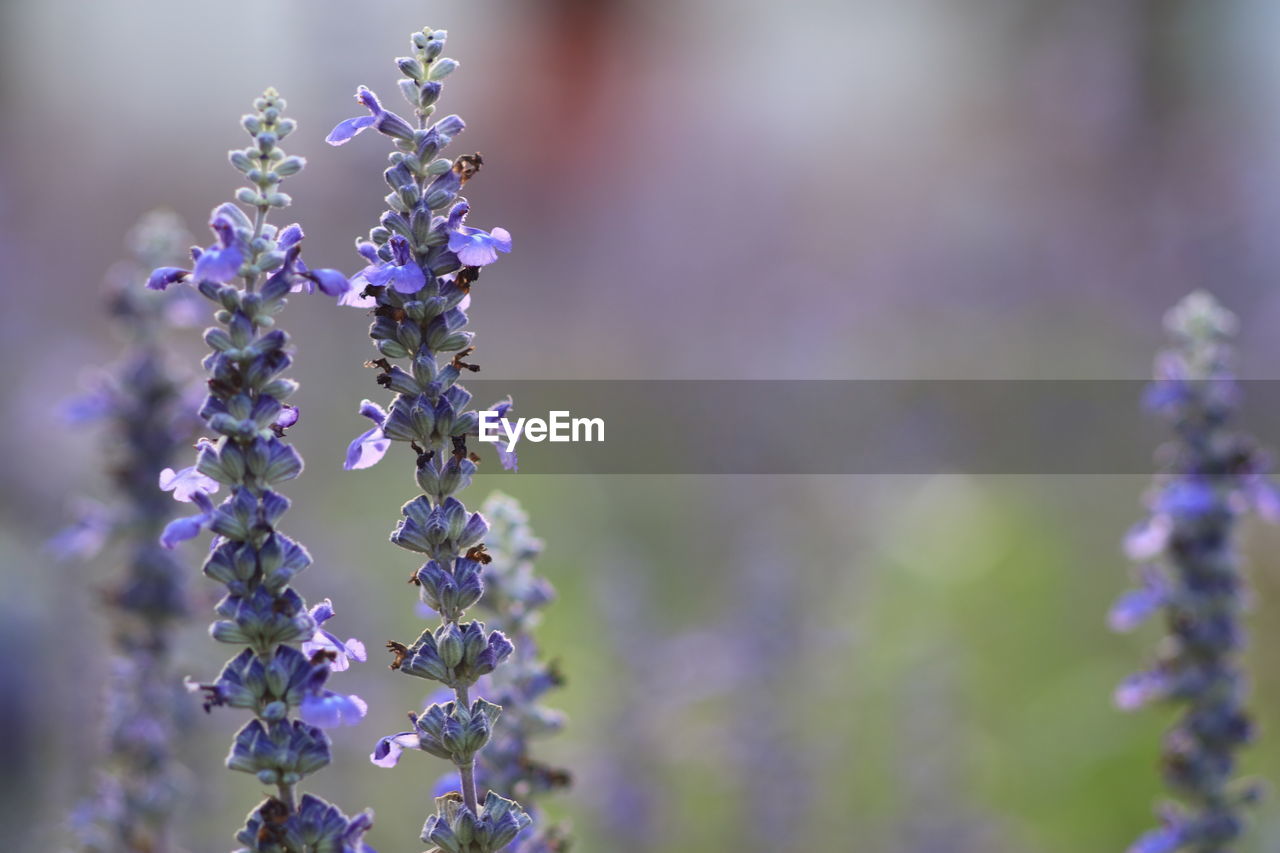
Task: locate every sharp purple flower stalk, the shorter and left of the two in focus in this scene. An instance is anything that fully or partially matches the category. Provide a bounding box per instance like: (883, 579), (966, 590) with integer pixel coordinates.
(148, 90), (372, 853)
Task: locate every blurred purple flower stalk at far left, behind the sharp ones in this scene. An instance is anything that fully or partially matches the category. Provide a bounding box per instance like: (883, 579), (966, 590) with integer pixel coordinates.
(52, 211), (195, 853)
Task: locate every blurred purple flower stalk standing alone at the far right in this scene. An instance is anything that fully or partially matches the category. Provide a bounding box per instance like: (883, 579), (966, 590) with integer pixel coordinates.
(1111, 293), (1277, 853)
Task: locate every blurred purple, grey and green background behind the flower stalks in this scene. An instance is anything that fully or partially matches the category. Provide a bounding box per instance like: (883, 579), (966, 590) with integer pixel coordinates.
(0, 0), (1280, 853)
